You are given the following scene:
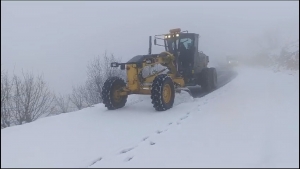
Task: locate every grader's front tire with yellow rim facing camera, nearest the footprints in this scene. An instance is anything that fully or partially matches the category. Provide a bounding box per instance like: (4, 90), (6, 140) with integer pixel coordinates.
(151, 74), (175, 111)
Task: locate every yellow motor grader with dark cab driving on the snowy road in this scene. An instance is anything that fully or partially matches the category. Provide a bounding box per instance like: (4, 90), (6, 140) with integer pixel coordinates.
(101, 28), (217, 111)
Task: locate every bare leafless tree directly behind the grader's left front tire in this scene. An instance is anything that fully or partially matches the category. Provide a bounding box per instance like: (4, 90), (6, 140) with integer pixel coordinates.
(86, 51), (125, 104)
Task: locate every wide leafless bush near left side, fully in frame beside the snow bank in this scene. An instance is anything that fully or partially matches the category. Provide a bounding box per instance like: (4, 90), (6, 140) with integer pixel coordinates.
(11, 73), (54, 124)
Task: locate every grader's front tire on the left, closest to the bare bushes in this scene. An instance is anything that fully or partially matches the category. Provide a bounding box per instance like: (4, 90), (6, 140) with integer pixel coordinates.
(101, 77), (128, 110)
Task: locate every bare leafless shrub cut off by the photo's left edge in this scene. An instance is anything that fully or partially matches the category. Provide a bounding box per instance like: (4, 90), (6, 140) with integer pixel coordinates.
(1, 70), (13, 129)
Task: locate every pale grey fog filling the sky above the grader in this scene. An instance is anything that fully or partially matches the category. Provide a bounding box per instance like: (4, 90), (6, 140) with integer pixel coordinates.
(1, 1), (299, 93)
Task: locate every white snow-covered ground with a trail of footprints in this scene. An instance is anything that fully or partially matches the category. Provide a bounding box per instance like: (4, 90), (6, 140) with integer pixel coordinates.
(1, 68), (299, 167)
